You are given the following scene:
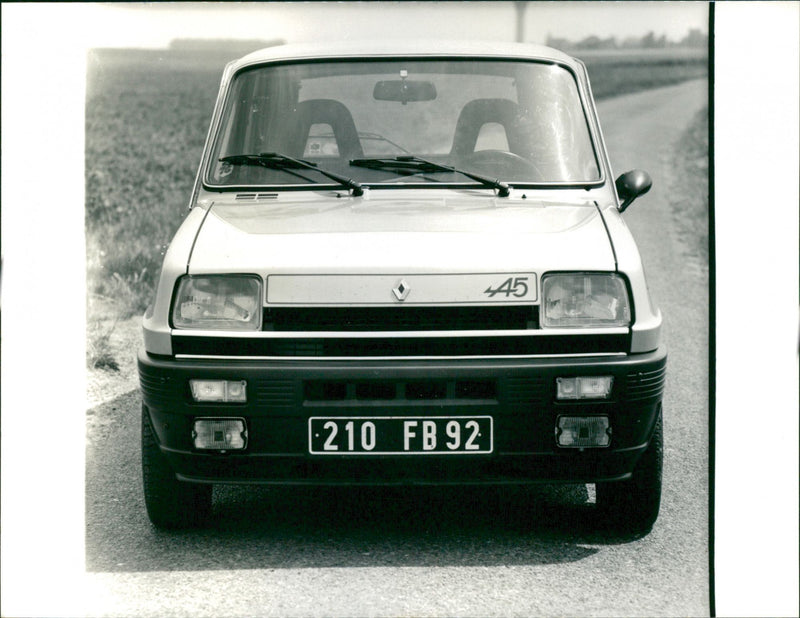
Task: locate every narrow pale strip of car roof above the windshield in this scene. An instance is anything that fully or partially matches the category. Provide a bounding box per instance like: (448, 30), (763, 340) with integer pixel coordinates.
(226, 39), (579, 74)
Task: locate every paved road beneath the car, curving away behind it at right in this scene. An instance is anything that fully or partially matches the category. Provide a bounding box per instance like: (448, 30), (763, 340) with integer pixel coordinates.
(86, 81), (709, 617)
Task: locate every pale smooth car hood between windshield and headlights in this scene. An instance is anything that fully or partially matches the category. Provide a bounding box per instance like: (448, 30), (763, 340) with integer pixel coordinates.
(189, 190), (615, 276)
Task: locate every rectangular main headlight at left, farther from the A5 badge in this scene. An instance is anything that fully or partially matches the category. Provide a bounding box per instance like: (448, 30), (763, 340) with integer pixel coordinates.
(172, 275), (261, 330)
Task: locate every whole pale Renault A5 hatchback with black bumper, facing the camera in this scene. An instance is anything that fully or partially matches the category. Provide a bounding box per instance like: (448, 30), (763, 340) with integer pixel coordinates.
(139, 42), (667, 533)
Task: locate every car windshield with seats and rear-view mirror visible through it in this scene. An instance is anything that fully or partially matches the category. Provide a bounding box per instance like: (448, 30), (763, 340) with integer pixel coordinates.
(206, 59), (601, 187)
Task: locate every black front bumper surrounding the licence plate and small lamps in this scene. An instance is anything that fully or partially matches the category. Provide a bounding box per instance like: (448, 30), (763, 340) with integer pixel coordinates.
(139, 348), (666, 485)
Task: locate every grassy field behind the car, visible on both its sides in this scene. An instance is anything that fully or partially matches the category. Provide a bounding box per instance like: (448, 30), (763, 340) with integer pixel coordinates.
(85, 45), (707, 369)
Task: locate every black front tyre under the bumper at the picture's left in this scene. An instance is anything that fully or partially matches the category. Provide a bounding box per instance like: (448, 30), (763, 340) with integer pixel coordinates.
(142, 406), (212, 528)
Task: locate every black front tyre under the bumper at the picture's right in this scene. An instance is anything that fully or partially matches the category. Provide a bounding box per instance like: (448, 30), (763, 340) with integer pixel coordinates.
(596, 406), (664, 534)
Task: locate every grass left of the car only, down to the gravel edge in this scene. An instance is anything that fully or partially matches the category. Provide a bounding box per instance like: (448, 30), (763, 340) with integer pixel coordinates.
(85, 51), (223, 318)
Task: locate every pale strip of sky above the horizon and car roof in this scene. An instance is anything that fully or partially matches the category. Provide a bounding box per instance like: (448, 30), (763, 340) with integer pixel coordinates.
(71, 2), (708, 48)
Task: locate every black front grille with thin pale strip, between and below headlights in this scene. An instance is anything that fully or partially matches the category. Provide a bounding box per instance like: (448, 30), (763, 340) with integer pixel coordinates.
(172, 305), (630, 359)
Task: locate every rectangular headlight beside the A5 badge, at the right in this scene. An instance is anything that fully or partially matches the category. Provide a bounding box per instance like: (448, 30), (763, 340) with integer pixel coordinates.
(542, 273), (631, 328)
